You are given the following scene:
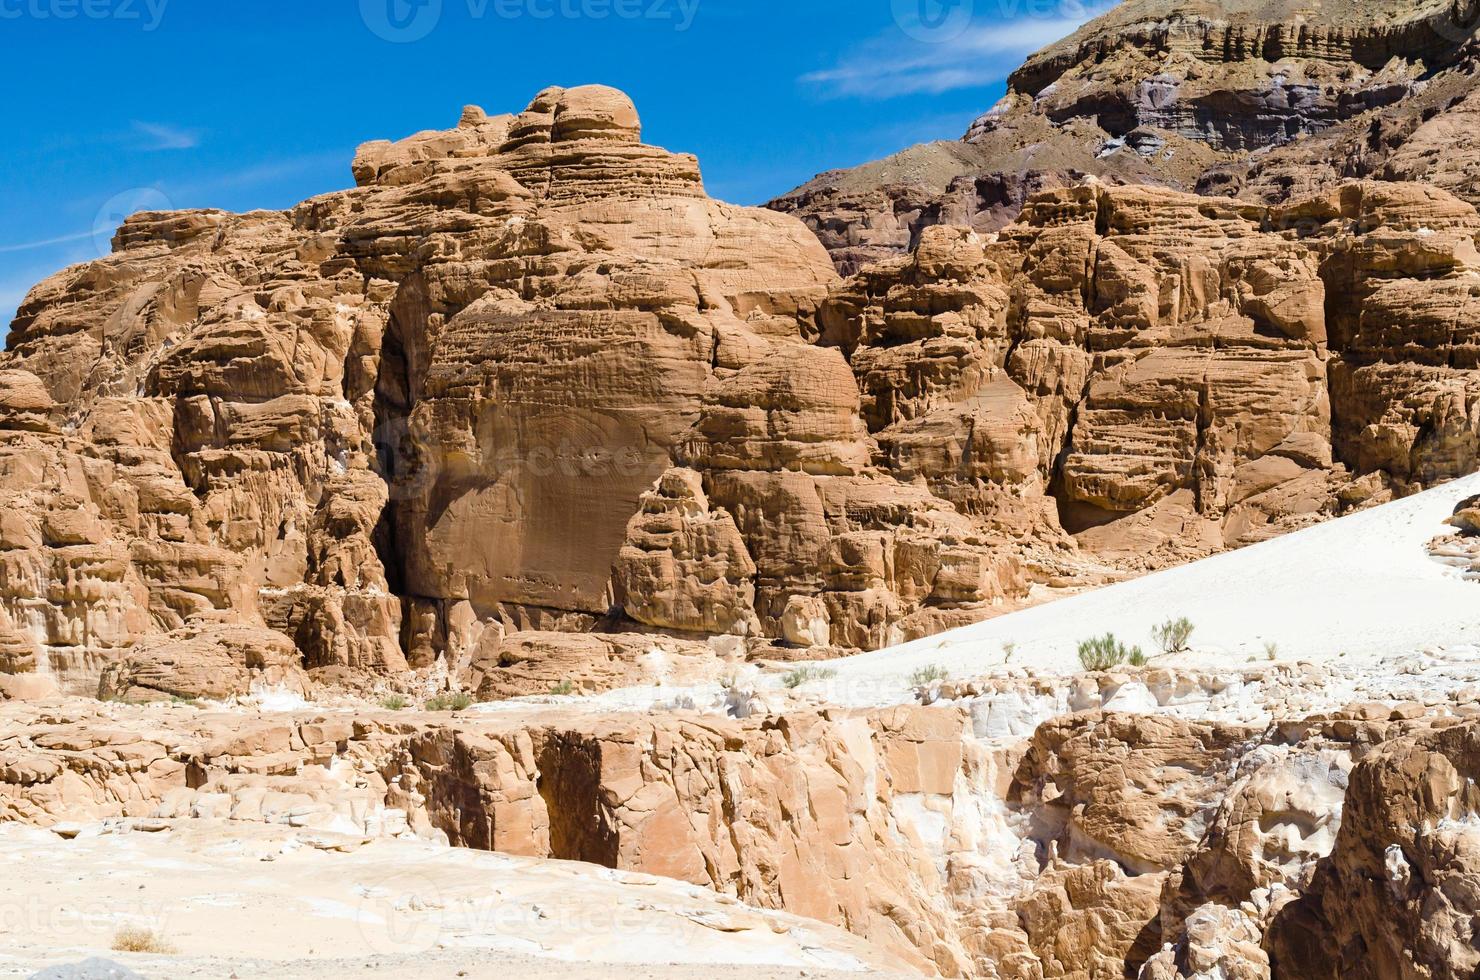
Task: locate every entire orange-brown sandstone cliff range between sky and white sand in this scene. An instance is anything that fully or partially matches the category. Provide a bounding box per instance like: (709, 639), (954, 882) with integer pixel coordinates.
(0, 87), (1480, 699)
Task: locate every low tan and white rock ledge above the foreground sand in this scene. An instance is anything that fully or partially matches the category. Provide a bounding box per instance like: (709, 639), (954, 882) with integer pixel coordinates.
(11, 683), (1474, 980)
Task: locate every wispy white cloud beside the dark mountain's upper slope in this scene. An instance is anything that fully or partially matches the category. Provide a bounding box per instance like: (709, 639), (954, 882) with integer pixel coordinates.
(802, 7), (1097, 99)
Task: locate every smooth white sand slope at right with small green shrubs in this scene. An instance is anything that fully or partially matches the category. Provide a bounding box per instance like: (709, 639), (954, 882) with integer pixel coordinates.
(808, 475), (1480, 705)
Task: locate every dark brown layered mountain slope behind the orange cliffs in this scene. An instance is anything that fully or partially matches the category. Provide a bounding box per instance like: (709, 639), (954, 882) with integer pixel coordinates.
(770, 0), (1480, 272)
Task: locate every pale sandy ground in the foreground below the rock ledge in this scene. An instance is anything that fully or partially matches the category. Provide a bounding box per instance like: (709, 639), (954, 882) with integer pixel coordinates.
(0, 822), (912, 980)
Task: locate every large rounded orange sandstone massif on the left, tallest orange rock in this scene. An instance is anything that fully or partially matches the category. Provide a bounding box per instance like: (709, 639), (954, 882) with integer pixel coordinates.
(0, 86), (1065, 693)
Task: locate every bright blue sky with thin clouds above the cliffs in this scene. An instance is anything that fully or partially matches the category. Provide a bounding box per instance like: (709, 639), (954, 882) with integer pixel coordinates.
(0, 0), (1088, 326)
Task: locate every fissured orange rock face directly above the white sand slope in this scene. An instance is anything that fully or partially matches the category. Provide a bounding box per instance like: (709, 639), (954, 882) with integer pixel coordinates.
(821, 182), (1480, 579)
